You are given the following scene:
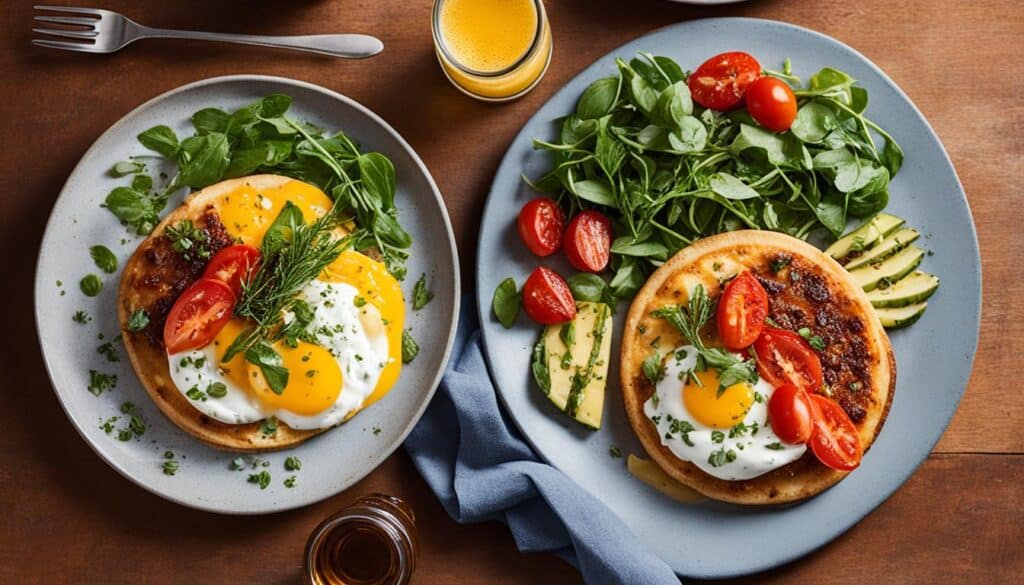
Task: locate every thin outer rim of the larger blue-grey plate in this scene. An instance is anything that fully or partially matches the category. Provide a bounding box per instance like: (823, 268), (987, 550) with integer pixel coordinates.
(474, 16), (983, 579)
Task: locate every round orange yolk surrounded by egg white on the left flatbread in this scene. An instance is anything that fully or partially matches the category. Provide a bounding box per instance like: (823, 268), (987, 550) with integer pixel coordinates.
(246, 341), (342, 416)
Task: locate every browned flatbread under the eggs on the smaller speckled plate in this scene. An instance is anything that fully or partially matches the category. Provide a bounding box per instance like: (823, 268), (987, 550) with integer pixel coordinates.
(118, 175), (326, 452)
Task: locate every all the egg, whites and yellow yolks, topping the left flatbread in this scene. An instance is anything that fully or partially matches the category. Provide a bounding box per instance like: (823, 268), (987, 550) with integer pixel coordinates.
(168, 181), (404, 429)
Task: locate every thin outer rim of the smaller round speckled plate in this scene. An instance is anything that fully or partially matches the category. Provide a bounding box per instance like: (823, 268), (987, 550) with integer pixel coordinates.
(33, 74), (462, 516)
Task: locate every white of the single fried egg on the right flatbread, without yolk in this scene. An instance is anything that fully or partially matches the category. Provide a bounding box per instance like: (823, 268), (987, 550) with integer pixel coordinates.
(644, 345), (807, 480)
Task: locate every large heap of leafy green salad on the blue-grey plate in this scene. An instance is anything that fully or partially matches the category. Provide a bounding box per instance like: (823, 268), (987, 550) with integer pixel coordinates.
(523, 53), (903, 298)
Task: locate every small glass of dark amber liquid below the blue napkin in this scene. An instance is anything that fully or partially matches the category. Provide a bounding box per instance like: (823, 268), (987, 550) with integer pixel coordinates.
(303, 494), (417, 585)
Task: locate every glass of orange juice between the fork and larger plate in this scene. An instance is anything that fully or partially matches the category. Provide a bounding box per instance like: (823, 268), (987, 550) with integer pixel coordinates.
(432, 0), (551, 101)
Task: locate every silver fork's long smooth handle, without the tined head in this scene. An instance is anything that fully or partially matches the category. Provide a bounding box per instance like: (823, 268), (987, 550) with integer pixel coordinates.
(132, 26), (384, 58)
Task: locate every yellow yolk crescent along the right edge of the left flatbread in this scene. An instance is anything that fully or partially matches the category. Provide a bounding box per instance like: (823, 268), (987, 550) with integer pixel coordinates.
(319, 250), (406, 408)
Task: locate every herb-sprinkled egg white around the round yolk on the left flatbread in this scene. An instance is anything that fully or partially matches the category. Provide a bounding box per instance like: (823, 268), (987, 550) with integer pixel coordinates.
(168, 280), (390, 429)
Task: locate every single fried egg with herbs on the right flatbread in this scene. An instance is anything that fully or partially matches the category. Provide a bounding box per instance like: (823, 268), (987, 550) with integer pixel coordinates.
(644, 345), (807, 480)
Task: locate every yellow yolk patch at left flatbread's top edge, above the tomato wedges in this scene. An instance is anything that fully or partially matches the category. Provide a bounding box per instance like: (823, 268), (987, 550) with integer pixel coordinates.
(214, 180), (333, 248)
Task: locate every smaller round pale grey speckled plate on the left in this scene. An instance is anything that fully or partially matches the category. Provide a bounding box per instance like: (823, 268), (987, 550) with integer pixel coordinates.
(36, 75), (459, 513)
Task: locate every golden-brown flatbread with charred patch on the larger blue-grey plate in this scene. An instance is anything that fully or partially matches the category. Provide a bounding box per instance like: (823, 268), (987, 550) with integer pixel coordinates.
(621, 229), (896, 504)
